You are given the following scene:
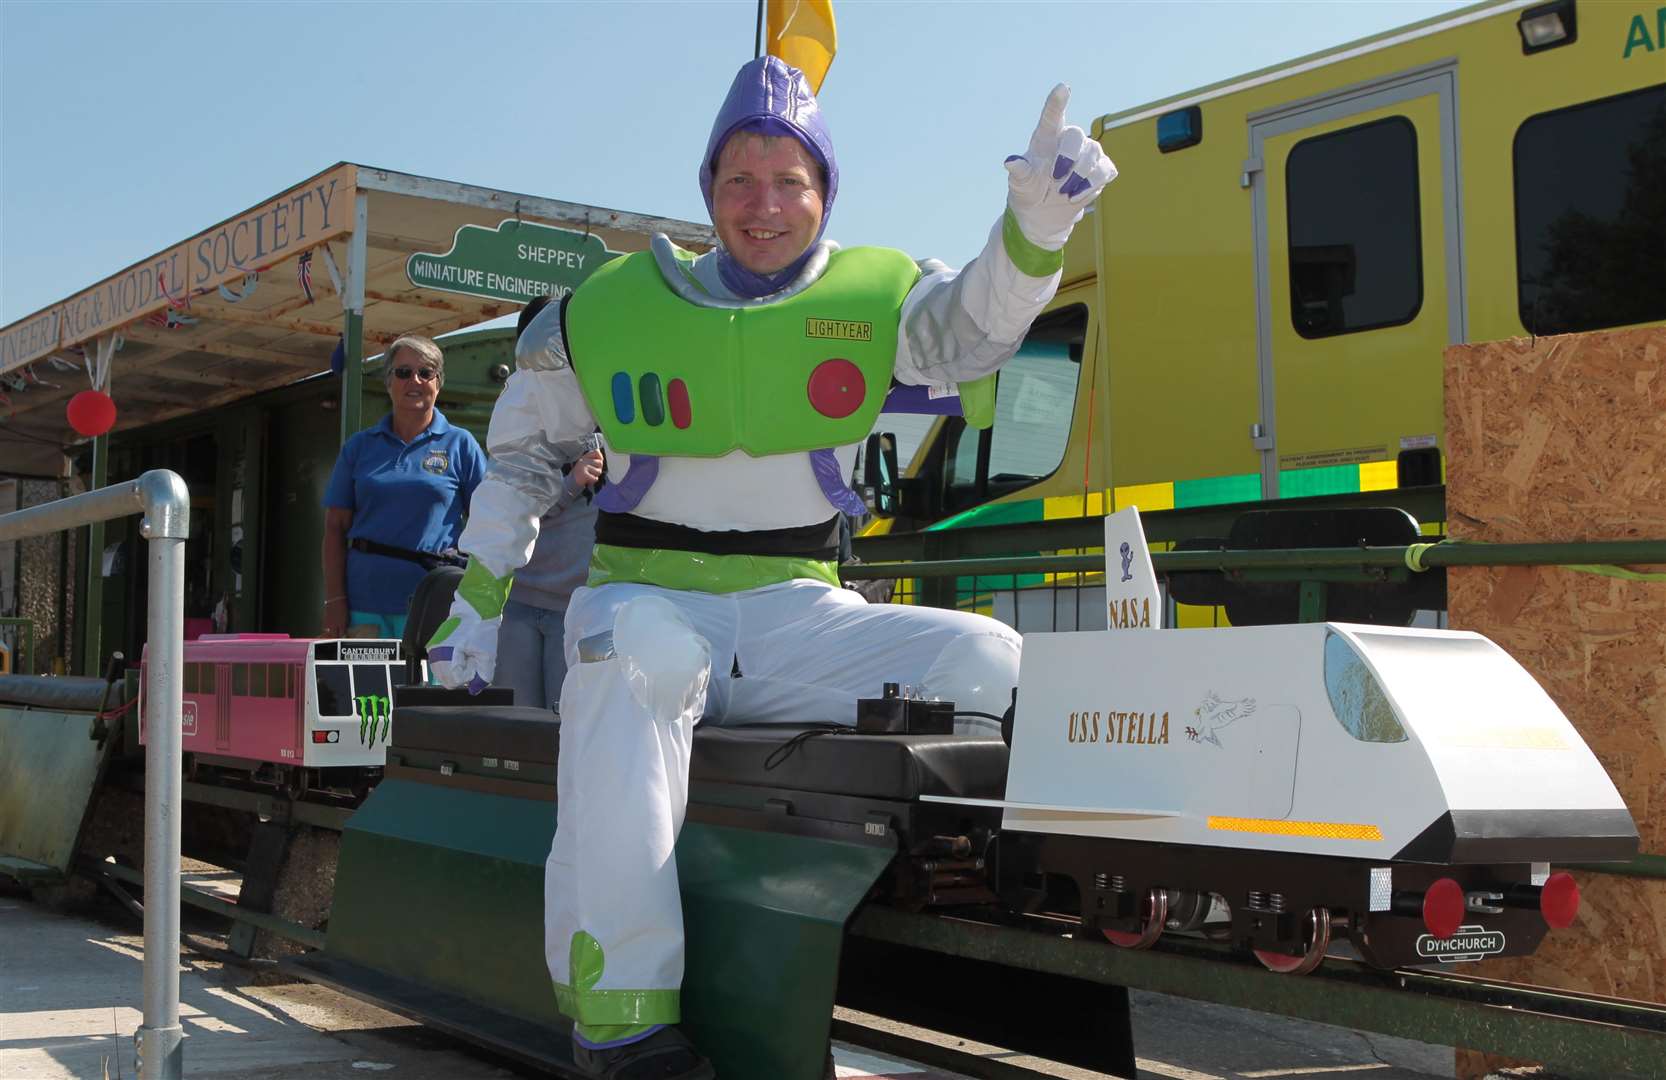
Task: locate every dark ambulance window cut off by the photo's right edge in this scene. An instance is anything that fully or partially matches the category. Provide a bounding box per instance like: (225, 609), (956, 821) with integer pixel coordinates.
(1514, 85), (1666, 333)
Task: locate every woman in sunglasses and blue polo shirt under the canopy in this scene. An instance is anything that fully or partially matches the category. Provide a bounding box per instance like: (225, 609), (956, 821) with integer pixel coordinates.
(323, 333), (486, 637)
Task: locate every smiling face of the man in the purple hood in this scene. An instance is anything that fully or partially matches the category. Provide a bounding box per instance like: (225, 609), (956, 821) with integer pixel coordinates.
(711, 132), (821, 273)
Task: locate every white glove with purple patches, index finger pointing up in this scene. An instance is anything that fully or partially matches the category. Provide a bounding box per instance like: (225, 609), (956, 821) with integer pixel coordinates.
(1006, 83), (1116, 252)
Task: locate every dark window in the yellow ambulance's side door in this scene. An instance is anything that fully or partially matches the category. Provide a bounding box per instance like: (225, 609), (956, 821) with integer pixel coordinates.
(1284, 117), (1423, 338)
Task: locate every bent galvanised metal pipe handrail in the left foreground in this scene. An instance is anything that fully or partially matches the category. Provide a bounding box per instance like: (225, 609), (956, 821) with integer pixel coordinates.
(0, 468), (192, 1080)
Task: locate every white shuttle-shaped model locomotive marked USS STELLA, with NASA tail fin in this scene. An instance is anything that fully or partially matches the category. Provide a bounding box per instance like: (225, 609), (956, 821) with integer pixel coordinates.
(932, 512), (1638, 972)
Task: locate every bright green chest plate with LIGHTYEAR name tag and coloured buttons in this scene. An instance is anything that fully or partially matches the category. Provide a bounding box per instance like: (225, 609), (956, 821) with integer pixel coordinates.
(566, 248), (920, 457)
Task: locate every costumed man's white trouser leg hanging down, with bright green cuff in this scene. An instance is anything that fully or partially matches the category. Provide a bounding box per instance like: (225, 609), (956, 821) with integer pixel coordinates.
(545, 590), (711, 1038)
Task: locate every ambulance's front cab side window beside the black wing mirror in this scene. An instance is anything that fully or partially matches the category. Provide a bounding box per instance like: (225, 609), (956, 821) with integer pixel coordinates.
(945, 305), (1088, 512)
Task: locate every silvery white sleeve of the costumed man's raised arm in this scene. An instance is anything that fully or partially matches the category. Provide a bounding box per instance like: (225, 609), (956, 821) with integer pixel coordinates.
(896, 217), (1063, 387)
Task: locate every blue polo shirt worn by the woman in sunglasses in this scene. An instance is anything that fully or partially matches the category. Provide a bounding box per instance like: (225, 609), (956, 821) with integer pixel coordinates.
(323, 408), (486, 615)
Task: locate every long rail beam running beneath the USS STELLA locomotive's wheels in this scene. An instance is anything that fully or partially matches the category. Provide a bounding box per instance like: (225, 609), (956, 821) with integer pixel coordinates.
(851, 905), (1666, 1080)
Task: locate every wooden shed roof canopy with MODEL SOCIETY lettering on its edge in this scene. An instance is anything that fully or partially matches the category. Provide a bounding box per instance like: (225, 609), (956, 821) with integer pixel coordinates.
(0, 162), (715, 475)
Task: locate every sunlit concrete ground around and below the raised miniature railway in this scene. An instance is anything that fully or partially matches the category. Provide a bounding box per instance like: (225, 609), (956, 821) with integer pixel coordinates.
(0, 890), (1453, 1080)
